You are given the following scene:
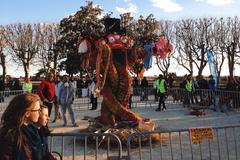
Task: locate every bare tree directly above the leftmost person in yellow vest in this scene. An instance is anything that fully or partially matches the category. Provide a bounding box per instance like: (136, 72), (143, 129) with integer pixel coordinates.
(4, 23), (40, 78)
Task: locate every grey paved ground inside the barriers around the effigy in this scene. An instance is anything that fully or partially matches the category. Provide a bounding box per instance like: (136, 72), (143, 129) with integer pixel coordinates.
(50, 103), (240, 132)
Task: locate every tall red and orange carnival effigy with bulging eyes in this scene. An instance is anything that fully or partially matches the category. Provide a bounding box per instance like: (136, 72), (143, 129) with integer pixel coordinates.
(78, 18), (172, 131)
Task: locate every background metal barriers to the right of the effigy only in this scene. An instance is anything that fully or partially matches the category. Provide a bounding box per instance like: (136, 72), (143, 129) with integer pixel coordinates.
(132, 88), (240, 111)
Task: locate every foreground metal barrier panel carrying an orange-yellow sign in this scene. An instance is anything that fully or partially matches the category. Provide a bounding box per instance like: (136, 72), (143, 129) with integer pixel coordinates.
(127, 125), (240, 160)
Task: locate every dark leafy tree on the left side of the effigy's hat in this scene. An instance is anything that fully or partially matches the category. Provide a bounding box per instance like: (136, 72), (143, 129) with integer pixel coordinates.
(57, 1), (104, 74)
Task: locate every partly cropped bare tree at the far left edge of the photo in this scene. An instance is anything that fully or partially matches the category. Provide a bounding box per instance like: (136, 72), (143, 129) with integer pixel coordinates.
(0, 26), (6, 80)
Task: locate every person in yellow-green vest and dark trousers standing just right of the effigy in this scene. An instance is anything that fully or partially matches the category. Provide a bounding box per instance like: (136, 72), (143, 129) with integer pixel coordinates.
(156, 74), (167, 111)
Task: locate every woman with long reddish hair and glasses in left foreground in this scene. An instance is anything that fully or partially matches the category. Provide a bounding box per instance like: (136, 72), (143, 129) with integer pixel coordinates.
(0, 93), (43, 160)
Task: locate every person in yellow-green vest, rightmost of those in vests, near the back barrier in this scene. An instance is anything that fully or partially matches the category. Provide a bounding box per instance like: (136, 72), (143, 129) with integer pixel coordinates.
(183, 75), (193, 107)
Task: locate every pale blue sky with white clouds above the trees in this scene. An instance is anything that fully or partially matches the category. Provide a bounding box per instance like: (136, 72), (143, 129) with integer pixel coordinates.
(0, 0), (240, 75)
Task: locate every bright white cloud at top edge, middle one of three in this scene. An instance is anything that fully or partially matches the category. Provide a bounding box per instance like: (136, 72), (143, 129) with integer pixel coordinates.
(152, 0), (183, 12)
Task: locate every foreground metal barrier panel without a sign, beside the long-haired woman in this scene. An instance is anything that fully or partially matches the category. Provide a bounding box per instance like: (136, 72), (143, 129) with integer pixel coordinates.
(49, 133), (122, 160)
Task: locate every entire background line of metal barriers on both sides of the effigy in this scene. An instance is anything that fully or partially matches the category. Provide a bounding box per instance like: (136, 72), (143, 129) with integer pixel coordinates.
(0, 88), (240, 112)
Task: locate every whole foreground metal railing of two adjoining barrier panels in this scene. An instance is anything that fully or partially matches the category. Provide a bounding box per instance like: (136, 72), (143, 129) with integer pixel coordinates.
(46, 124), (240, 160)
